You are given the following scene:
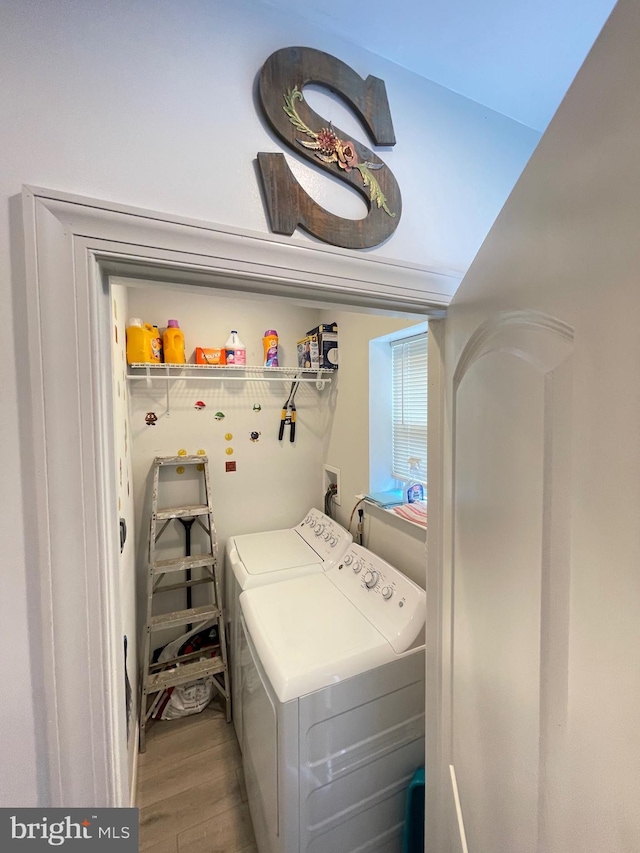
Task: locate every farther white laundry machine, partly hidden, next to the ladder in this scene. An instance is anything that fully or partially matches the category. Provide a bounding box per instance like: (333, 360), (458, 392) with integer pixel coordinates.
(224, 508), (353, 748)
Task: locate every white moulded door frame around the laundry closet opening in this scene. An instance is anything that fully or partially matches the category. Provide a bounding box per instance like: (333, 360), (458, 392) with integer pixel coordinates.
(22, 187), (459, 807)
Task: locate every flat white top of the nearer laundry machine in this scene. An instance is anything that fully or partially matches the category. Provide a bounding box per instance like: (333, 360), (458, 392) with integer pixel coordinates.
(240, 574), (396, 702)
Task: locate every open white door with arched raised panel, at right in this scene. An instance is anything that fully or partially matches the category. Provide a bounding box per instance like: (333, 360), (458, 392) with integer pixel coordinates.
(438, 0), (640, 853)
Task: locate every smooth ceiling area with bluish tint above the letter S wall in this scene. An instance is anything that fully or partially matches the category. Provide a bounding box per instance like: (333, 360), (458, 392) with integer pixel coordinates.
(266, 0), (615, 131)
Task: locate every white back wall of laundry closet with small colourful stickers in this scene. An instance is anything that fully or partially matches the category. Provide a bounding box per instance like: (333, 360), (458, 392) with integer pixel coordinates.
(124, 285), (324, 561)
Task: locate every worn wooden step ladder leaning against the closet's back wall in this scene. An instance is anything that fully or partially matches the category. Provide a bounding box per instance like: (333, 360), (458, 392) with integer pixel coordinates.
(140, 456), (231, 752)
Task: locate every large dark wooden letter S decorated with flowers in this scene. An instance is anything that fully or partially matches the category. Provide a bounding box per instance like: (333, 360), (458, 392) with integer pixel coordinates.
(258, 47), (402, 249)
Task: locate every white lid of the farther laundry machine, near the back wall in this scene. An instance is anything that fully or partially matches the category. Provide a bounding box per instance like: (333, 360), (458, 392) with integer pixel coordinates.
(235, 529), (322, 575)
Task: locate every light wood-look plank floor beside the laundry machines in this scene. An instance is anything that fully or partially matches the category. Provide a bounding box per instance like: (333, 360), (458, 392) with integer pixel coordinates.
(137, 699), (257, 853)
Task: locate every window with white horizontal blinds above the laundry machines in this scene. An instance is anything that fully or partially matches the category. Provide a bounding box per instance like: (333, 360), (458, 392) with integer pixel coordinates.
(391, 334), (427, 483)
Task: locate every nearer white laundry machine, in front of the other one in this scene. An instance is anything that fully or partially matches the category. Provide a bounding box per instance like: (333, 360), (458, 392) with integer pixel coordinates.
(240, 543), (426, 853)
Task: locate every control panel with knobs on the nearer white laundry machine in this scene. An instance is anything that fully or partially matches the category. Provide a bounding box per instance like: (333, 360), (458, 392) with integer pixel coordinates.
(327, 542), (427, 654)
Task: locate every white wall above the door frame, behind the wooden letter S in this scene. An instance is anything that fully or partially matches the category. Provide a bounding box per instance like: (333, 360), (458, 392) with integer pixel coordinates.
(0, 0), (538, 806)
